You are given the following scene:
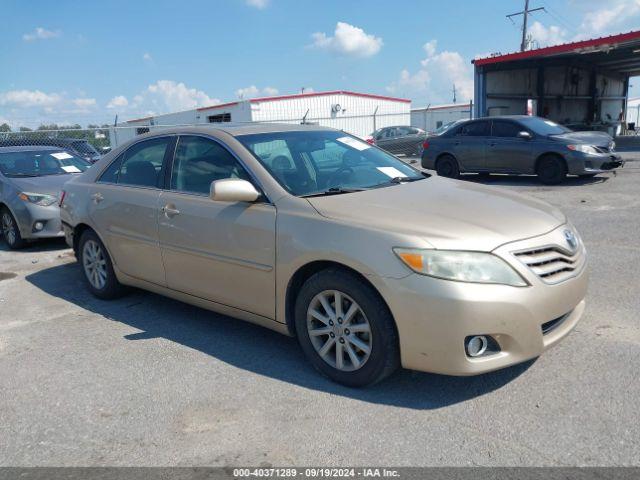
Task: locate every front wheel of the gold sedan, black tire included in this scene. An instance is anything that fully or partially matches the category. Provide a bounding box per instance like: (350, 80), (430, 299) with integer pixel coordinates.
(295, 268), (400, 387)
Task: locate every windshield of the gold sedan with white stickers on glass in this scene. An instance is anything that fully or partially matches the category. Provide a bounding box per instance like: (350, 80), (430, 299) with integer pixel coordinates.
(236, 130), (425, 196)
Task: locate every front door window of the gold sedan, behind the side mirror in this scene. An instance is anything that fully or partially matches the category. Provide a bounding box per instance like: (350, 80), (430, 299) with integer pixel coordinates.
(171, 136), (249, 195)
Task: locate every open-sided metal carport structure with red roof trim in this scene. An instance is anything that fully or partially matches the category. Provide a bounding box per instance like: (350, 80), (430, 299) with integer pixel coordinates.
(473, 31), (640, 133)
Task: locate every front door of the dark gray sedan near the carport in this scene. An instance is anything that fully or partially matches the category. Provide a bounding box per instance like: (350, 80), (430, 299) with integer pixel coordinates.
(486, 120), (535, 173)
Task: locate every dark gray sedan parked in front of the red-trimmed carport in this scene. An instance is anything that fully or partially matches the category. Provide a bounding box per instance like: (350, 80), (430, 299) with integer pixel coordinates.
(422, 115), (624, 184)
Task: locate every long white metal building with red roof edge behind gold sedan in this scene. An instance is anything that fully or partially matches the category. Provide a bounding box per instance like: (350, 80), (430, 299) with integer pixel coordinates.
(111, 90), (411, 147)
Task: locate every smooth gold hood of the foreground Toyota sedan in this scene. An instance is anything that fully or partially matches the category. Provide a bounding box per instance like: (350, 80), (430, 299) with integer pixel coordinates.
(307, 177), (566, 252)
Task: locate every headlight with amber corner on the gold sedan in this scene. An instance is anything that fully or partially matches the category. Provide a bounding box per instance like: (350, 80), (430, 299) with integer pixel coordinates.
(393, 248), (527, 287)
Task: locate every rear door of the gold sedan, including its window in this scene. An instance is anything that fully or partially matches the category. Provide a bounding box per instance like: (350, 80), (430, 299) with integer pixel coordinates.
(88, 137), (174, 285)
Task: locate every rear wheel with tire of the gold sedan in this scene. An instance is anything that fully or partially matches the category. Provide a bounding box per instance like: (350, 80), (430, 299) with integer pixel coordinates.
(78, 230), (126, 300)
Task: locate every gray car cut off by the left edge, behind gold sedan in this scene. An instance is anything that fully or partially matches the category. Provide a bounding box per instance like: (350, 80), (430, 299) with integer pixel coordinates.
(0, 146), (90, 249)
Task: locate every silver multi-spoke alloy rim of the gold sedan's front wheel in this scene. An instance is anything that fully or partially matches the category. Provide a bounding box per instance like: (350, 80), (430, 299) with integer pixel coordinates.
(307, 290), (372, 372)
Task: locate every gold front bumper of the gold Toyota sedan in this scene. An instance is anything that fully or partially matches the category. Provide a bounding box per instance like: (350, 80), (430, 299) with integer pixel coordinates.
(372, 227), (588, 375)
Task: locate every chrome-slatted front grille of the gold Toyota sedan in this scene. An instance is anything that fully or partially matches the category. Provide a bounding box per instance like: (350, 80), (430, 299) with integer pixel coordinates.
(513, 246), (584, 284)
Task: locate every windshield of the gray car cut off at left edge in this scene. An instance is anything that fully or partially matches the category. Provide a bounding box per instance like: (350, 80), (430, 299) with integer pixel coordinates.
(0, 150), (90, 177)
